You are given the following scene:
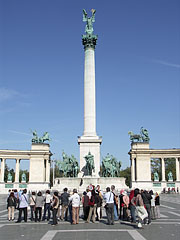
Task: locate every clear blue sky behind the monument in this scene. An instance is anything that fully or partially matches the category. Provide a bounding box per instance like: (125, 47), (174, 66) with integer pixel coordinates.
(0, 0), (180, 172)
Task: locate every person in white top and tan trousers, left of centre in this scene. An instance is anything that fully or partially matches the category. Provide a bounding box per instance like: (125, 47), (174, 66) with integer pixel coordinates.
(69, 189), (80, 224)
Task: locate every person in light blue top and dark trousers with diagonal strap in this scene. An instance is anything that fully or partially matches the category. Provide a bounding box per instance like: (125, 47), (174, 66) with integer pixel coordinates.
(16, 189), (28, 223)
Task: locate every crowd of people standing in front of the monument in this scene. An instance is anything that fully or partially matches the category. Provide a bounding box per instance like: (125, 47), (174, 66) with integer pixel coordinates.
(7, 184), (160, 228)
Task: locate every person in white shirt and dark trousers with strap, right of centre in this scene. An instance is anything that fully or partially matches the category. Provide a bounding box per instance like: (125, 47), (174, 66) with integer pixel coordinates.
(104, 187), (114, 225)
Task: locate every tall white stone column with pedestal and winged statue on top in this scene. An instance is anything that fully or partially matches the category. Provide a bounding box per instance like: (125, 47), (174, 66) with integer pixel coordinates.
(78, 10), (102, 177)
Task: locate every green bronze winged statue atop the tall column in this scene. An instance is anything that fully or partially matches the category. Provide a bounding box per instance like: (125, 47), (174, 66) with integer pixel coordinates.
(83, 9), (96, 35)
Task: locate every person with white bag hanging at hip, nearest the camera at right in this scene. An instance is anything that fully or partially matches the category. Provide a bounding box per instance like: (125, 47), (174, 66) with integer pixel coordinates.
(131, 188), (148, 228)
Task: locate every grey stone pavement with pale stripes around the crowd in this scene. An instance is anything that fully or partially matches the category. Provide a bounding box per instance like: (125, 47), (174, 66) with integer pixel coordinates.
(0, 194), (180, 240)
